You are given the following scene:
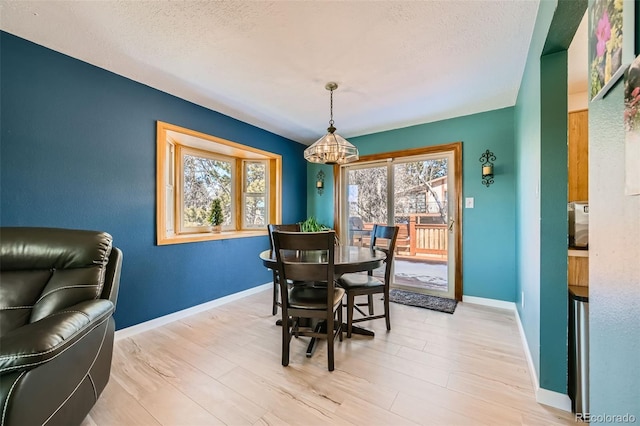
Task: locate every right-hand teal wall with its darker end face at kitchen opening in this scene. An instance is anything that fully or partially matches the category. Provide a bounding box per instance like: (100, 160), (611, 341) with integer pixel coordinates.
(515, 1), (586, 400)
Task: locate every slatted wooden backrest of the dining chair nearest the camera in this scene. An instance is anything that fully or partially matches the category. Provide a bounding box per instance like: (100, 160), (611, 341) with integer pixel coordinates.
(273, 231), (335, 309)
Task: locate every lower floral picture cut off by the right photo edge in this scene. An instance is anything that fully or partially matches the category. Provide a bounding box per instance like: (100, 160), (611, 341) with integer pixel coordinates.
(624, 56), (640, 195)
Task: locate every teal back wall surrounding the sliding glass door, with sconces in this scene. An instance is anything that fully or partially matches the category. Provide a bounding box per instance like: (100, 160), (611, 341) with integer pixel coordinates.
(307, 108), (516, 302)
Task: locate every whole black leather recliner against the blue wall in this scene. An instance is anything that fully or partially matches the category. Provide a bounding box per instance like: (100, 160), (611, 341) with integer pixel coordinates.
(0, 228), (122, 426)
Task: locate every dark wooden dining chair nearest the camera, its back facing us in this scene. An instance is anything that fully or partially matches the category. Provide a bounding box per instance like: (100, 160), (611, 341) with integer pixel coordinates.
(273, 231), (345, 371)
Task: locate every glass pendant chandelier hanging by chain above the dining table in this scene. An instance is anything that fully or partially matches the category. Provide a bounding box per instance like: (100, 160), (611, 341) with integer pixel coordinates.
(304, 82), (358, 164)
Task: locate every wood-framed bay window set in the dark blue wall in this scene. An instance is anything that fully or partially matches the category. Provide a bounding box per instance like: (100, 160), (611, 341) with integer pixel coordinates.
(156, 121), (282, 245)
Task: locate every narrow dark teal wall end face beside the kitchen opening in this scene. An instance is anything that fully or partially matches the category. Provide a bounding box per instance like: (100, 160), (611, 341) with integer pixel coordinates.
(540, 50), (568, 393)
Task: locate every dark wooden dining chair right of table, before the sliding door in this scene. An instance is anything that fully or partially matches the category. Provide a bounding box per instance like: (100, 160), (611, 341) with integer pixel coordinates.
(338, 224), (399, 337)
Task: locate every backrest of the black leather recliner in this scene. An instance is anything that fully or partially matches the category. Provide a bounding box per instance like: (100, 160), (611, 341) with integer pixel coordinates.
(0, 228), (122, 335)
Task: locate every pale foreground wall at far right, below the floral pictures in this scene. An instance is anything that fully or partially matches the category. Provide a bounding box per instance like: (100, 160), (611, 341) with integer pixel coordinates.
(589, 2), (640, 416)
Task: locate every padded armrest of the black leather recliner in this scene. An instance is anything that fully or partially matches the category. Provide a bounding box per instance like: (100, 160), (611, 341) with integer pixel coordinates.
(0, 299), (114, 373)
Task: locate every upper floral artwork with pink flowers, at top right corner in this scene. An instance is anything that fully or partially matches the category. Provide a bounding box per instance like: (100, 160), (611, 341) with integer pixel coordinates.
(589, 0), (635, 101)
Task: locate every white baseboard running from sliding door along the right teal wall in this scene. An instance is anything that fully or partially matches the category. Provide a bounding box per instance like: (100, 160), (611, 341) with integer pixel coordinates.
(462, 296), (571, 412)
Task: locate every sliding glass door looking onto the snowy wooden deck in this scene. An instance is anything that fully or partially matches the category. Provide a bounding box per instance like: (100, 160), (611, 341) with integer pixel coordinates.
(339, 146), (459, 298)
